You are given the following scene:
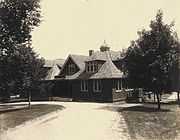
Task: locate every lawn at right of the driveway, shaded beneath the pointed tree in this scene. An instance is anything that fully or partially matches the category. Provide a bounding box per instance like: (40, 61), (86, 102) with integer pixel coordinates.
(118, 104), (180, 140)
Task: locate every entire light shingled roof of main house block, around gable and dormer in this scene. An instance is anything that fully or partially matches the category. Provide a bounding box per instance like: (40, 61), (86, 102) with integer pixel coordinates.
(54, 47), (123, 80)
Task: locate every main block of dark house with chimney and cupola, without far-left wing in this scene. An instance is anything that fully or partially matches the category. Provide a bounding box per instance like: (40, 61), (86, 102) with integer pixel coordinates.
(53, 43), (127, 102)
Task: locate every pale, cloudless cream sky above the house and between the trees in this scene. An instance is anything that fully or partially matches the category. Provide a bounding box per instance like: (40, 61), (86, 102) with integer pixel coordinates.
(32, 0), (180, 59)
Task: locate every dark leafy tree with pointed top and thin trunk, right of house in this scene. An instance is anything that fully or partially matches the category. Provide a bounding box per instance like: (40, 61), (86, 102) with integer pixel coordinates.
(124, 10), (179, 109)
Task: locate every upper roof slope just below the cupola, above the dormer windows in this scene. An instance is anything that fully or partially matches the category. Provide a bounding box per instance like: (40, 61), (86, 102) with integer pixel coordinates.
(87, 51), (121, 61)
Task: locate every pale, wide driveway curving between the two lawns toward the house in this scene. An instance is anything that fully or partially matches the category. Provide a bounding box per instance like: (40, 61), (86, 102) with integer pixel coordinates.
(0, 102), (129, 140)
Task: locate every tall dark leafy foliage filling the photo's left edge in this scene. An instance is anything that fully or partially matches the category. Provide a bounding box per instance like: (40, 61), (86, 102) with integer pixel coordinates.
(0, 0), (44, 97)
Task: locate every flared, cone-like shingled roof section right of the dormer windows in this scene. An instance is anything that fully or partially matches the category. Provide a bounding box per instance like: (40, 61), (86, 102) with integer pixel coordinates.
(90, 51), (123, 79)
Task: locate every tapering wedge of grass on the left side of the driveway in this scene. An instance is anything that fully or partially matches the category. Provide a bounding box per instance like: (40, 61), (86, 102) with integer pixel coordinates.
(0, 104), (64, 133)
